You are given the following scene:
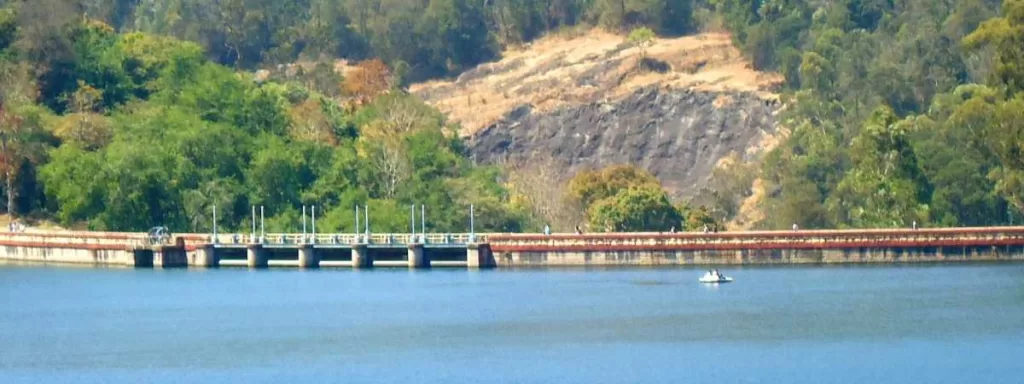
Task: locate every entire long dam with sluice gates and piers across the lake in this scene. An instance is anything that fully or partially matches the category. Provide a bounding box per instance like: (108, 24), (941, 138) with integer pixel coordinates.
(0, 226), (1024, 268)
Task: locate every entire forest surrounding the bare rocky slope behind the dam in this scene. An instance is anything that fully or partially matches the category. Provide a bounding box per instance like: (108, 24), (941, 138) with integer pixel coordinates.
(0, 0), (1024, 231)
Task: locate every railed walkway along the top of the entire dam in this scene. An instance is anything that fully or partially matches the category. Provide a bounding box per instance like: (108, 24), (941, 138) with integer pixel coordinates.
(0, 226), (1024, 252)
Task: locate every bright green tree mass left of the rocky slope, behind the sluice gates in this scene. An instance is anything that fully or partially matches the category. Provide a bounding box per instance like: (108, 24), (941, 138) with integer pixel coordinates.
(0, 12), (529, 231)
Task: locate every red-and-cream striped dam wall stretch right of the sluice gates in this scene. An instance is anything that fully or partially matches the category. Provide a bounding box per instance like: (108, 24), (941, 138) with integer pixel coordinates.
(489, 227), (1024, 266)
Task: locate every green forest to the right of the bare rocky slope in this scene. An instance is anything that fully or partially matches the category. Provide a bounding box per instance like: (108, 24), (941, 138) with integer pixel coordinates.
(719, 0), (1024, 228)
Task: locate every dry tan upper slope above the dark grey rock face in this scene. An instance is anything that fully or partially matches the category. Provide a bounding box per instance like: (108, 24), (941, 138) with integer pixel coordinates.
(411, 31), (781, 136)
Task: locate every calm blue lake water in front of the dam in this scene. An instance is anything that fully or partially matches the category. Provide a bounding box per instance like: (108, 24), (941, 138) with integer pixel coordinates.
(0, 264), (1024, 383)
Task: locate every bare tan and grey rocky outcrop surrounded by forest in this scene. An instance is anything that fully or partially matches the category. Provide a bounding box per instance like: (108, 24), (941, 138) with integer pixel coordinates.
(412, 28), (779, 198)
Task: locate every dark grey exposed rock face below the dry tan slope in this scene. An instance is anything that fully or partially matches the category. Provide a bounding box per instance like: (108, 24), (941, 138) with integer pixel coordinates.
(468, 87), (779, 198)
